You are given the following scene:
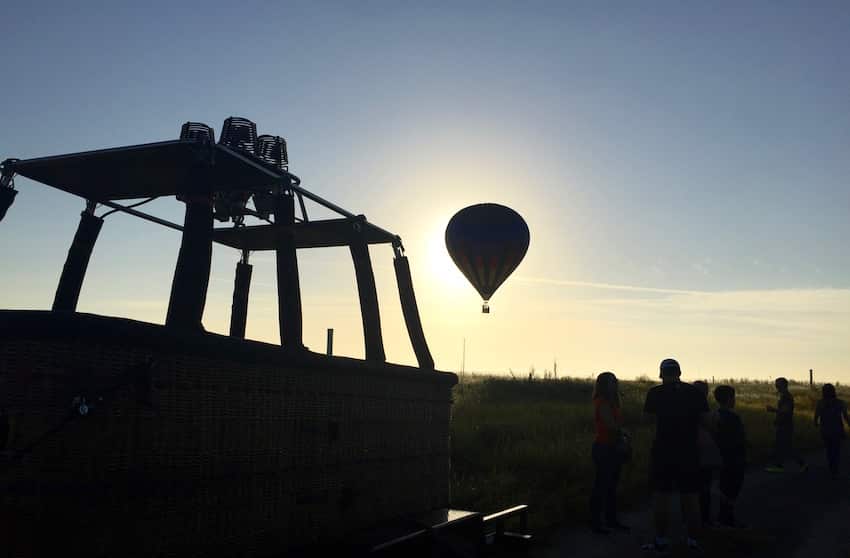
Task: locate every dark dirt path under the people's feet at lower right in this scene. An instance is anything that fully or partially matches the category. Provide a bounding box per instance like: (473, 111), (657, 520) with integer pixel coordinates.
(530, 444), (850, 558)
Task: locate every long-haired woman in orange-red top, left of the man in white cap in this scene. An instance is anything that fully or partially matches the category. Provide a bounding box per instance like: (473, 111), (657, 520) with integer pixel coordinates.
(590, 372), (628, 534)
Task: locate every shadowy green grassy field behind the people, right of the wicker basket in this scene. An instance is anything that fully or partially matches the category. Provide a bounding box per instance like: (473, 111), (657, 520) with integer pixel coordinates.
(451, 375), (850, 528)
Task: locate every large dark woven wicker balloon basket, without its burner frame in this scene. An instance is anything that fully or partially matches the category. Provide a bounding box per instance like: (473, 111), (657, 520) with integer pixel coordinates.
(0, 311), (457, 556)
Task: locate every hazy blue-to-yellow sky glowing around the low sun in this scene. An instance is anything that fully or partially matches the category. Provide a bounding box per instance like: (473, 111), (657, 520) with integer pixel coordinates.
(0, 1), (850, 382)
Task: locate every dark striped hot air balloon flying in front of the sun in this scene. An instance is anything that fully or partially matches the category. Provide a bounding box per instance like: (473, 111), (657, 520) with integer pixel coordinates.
(446, 203), (530, 314)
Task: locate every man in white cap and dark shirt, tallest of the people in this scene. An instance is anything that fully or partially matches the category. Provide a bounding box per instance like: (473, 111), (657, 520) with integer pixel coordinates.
(643, 358), (708, 552)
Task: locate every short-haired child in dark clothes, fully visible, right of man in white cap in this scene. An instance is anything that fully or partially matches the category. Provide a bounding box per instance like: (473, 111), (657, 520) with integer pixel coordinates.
(714, 386), (747, 527)
